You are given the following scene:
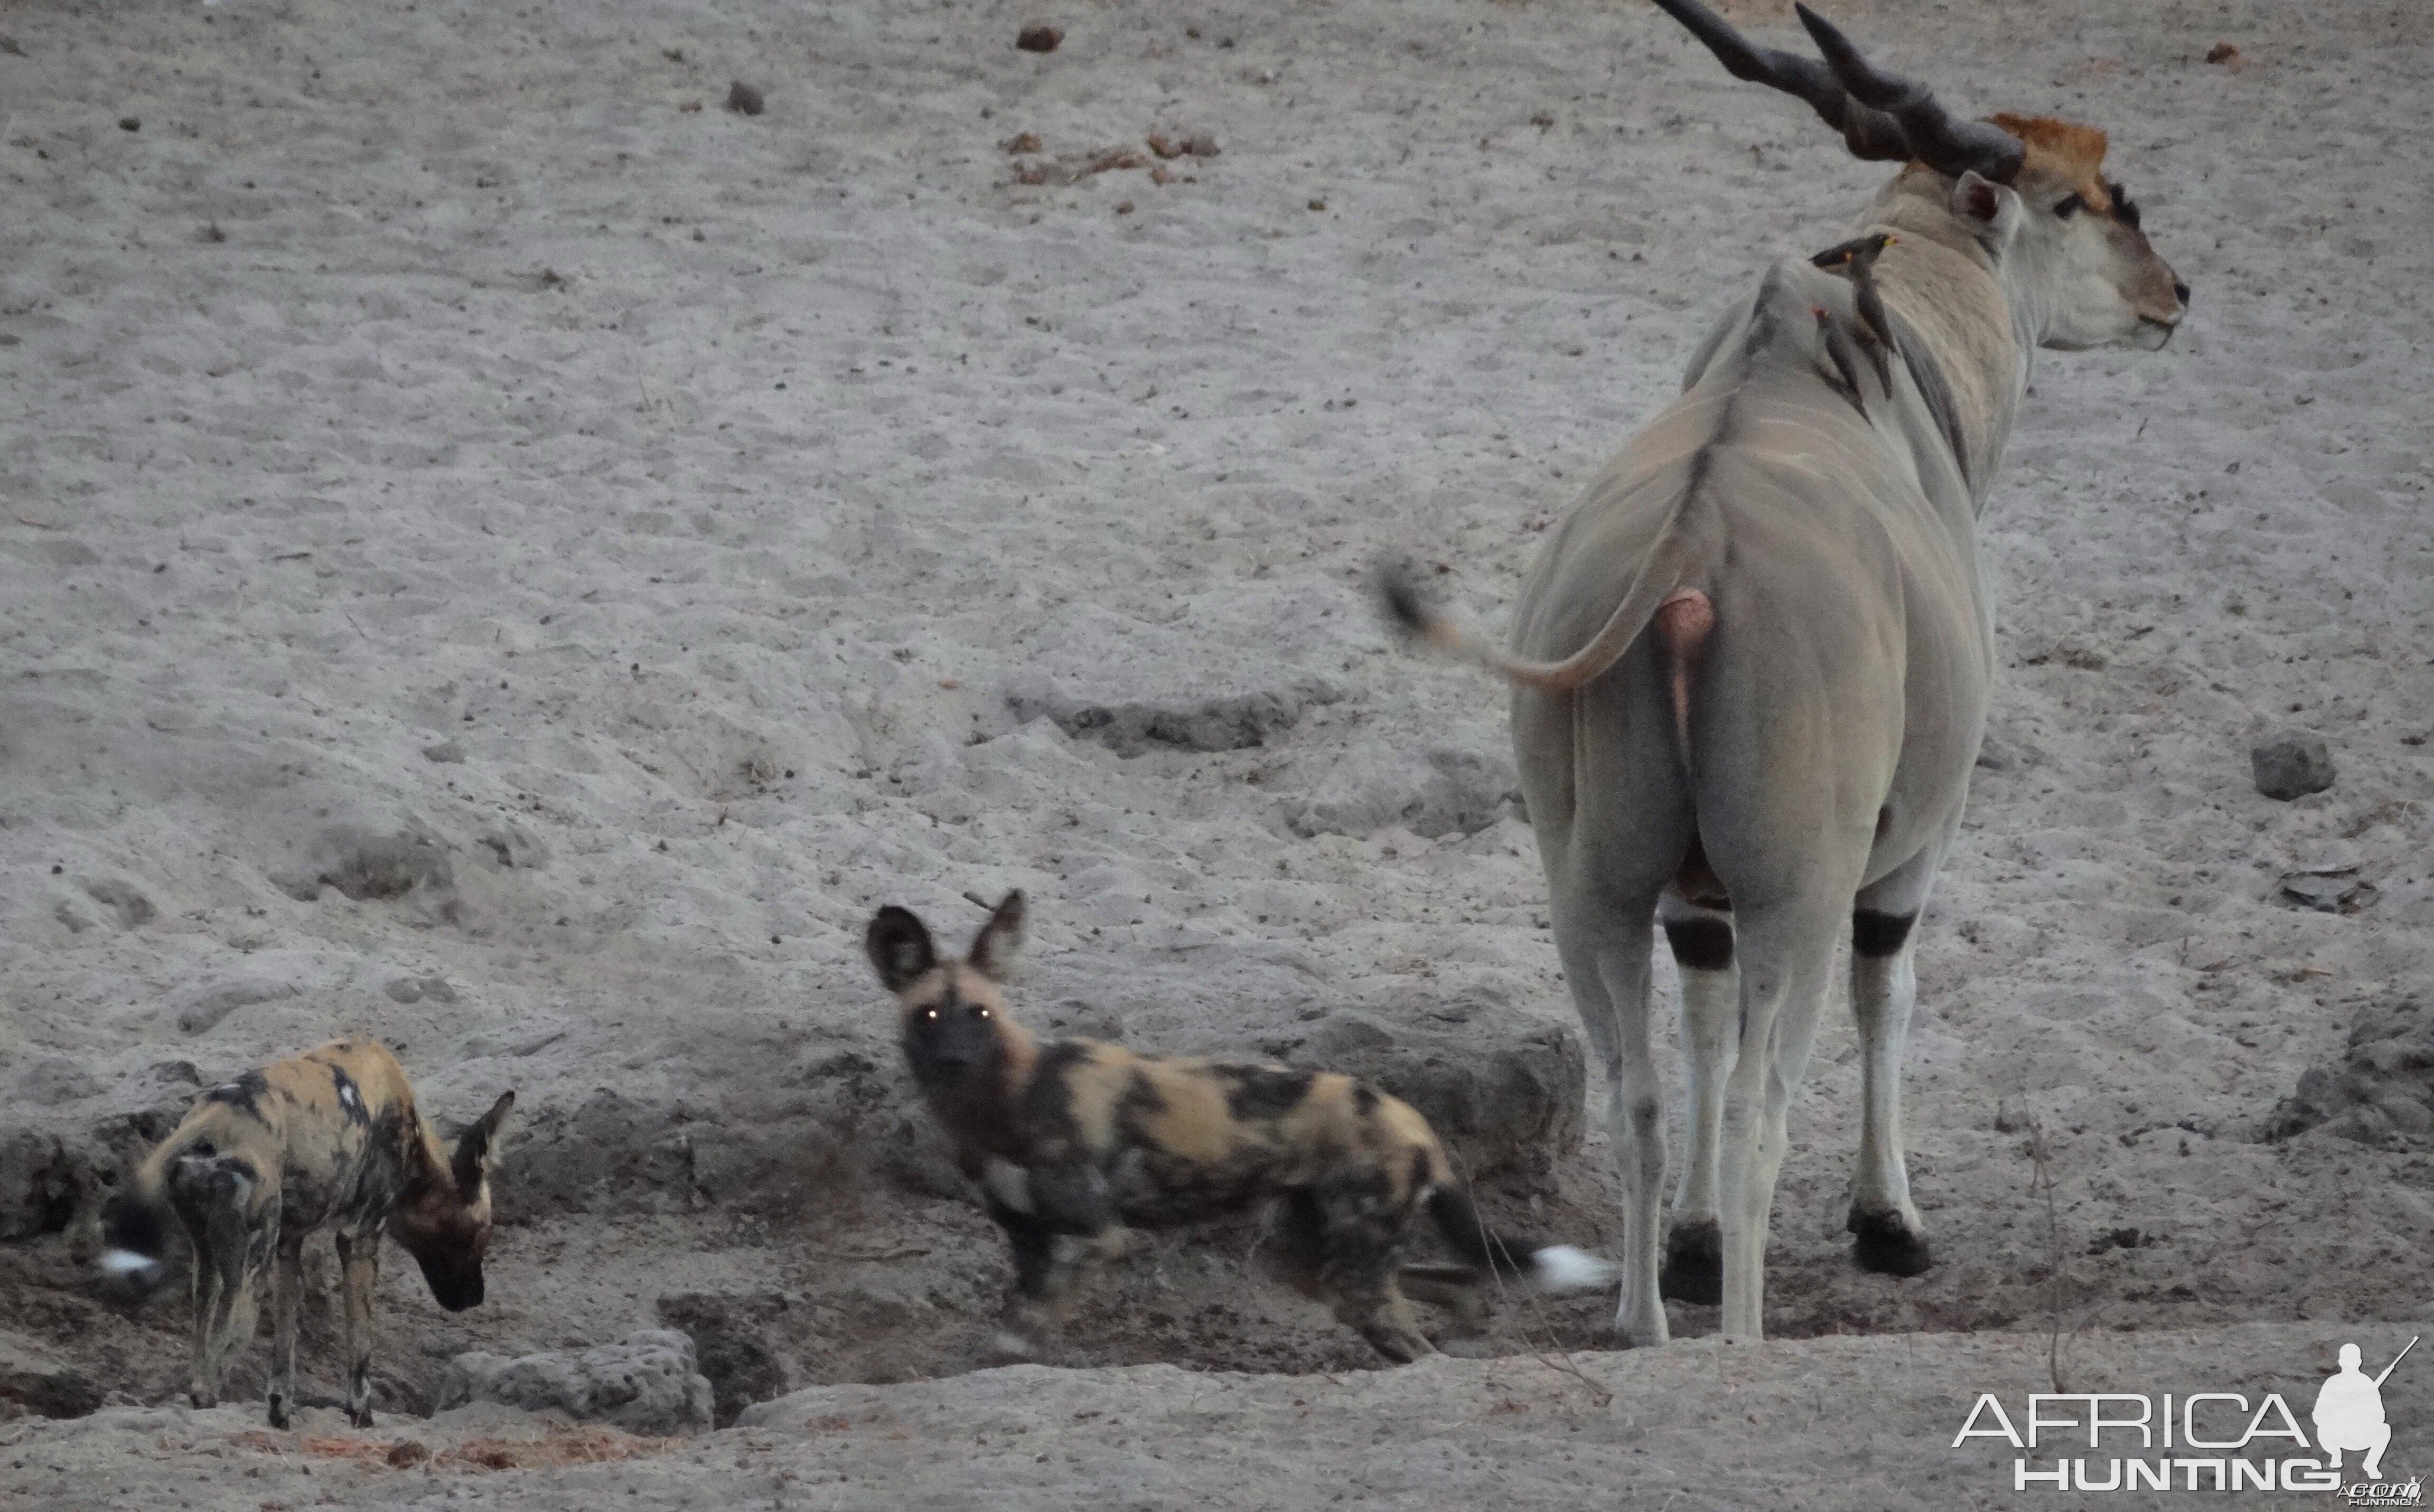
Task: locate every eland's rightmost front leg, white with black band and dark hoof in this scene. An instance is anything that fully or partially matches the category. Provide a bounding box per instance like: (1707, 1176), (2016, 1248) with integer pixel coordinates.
(1850, 833), (1952, 1276)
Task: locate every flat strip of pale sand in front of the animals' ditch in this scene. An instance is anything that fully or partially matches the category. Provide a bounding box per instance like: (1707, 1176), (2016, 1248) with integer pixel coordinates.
(0, 1325), (2434, 1512)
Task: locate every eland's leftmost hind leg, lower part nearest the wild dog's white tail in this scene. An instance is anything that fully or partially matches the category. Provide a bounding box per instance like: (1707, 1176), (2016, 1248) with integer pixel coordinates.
(1556, 889), (1670, 1344)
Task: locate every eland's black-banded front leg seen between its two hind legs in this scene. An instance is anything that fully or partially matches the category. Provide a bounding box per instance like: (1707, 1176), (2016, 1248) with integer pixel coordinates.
(1658, 891), (1740, 1308)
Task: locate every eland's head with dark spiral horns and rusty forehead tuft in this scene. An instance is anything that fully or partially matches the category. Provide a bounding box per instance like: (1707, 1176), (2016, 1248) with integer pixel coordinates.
(1655, 0), (2188, 351)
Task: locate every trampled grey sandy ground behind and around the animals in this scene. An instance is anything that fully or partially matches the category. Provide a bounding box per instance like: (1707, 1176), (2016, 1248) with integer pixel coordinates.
(0, 0), (2434, 1505)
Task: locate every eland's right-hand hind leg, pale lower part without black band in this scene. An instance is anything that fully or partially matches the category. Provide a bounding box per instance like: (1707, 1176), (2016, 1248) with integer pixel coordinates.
(1721, 879), (1850, 1339)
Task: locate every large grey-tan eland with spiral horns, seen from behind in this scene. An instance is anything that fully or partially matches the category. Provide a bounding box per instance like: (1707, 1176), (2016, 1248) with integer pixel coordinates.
(1382, 0), (2188, 1344)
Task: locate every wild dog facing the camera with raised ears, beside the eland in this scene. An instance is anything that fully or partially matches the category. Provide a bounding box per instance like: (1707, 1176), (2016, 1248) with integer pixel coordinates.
(864, 894), (1614, 1361)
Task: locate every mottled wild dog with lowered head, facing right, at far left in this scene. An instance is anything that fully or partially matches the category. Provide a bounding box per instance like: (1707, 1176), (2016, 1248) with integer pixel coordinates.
(100, 1040), (516, 1427)
